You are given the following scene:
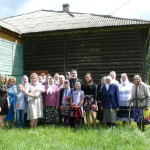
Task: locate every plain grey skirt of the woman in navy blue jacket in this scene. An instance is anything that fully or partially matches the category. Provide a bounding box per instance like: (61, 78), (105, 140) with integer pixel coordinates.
(103, 109), (117, 123)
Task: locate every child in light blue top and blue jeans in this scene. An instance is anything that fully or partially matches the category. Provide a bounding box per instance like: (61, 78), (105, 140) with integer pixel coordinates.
(14, 84), (27, 128)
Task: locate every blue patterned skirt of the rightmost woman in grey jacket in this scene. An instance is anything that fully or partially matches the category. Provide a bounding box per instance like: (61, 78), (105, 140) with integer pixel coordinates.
(134, 107), (144, 123)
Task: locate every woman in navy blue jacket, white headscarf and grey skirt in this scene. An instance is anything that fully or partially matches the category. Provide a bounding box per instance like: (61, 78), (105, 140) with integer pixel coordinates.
(101, 76), (120, 127)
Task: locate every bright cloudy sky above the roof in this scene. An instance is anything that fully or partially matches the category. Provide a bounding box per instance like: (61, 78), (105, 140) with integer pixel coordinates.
(0, 0), (150, 20)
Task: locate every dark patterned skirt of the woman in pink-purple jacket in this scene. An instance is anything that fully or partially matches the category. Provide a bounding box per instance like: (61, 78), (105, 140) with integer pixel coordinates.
(44, 106), (59, 124)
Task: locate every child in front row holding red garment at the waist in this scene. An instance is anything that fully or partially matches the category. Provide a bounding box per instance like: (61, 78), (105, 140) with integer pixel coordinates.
(71, 82), (84, 128)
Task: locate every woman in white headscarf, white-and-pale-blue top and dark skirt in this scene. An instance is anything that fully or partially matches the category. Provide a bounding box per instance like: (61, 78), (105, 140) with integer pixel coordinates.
(117, 73), (133, 125)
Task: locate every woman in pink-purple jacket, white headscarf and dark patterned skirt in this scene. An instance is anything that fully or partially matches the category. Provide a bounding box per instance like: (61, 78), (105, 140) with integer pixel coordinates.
(44, 78), (60, 124)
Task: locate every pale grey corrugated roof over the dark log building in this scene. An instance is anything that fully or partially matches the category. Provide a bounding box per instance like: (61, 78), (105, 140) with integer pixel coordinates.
(2, 10), (150, 34)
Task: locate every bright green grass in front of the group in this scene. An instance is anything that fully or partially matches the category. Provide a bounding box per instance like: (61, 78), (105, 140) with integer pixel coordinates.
(0, 125), (150, 150)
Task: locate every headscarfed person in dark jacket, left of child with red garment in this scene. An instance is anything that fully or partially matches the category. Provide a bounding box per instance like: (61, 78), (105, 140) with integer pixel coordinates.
(60, 80), (71, 126)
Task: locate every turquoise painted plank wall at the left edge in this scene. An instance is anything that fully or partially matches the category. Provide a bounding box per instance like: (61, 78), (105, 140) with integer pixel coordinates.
(0, 39), (23, 82)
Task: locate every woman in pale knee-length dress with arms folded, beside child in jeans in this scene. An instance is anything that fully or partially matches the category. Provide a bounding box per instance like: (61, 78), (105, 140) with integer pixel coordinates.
(25, 73), (45, 129)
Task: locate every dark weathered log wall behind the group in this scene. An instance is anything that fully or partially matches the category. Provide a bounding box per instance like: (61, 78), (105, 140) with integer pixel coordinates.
(24, 29), (146, 83)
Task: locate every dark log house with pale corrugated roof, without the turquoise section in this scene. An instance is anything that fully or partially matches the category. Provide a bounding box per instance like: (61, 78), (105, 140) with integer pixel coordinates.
(0, 5), (150, 83)
